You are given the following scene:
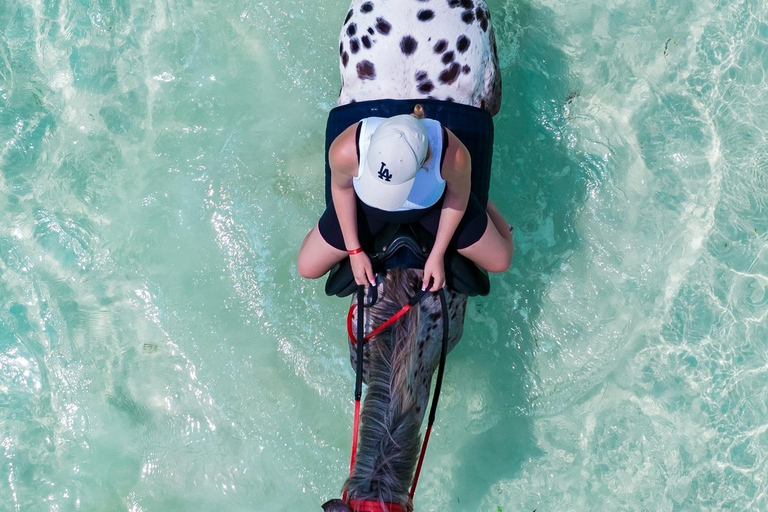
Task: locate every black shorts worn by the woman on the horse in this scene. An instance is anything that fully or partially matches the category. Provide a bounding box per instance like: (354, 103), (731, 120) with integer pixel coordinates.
(318, 194), (488, 251)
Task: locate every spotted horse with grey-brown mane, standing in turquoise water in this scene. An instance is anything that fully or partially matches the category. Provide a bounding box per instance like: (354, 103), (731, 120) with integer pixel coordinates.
(322, 0), (501, 512)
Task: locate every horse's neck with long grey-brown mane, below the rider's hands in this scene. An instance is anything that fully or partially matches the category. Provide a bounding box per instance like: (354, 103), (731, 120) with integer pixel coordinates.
(323, 268), (467, 512)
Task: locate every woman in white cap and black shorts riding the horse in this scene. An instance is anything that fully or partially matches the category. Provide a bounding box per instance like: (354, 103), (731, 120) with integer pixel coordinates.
(298, 105), (513, 291)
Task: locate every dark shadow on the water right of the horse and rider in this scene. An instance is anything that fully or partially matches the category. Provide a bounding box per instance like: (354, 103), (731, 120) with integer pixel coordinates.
(444, 3), (590, 510)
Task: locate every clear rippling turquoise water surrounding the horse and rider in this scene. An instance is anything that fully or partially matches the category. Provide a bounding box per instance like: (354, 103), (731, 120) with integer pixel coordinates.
(0, 0), (768, 512)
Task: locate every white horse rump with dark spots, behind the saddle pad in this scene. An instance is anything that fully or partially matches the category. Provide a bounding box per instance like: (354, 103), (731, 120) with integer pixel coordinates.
(338, 0), (501, 115)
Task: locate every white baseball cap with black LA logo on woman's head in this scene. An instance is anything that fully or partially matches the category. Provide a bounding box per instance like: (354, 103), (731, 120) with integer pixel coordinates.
(355, 114), (429, 212)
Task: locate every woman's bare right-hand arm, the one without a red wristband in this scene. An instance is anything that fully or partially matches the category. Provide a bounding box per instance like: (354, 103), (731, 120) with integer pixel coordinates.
(423, 130), (472, 291)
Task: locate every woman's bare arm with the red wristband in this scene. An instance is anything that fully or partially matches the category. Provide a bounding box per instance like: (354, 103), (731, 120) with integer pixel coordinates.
(328, 124), (376, 285)
